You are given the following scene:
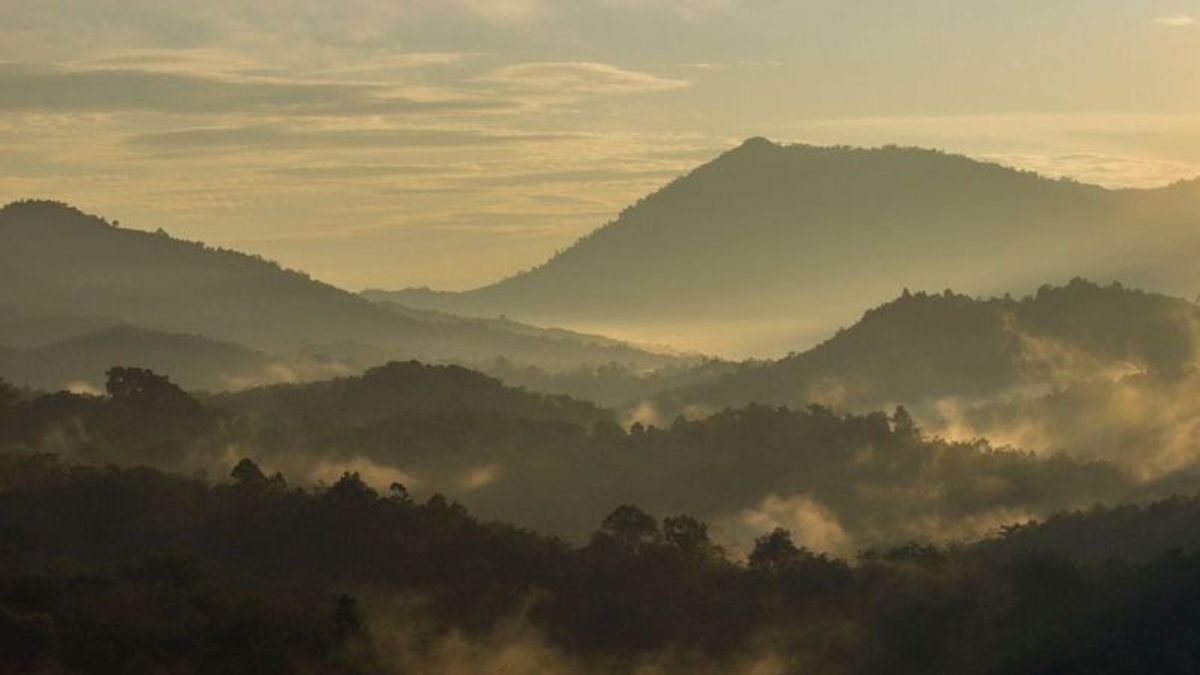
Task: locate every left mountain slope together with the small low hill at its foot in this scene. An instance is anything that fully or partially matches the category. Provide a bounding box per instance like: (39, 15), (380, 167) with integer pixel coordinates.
(0, 202), (680, 388)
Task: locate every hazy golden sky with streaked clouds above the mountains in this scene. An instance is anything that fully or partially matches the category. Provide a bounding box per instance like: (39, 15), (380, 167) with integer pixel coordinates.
(0, 0), (1200, 289)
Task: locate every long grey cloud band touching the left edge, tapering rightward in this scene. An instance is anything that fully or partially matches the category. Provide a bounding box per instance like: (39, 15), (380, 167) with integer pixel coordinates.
(0, 64), (516, 115)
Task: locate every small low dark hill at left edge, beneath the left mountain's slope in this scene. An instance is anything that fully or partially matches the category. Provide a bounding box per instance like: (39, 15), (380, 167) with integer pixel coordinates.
(0, 325), (278, 390)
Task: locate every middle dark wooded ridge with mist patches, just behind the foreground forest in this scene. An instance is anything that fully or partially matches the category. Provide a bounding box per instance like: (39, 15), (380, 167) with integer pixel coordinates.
(0, 364), (1180, 552)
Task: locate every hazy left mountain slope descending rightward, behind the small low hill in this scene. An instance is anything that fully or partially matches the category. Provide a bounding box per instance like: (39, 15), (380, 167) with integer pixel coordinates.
(0, 196), (677, 368)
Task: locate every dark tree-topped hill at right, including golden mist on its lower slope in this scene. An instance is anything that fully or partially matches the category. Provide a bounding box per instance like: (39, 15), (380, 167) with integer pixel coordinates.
(637, 279), (1200, 482)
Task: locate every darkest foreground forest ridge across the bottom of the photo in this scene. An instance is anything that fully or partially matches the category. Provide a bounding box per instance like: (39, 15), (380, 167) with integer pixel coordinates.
(7, 455), (1200, 675)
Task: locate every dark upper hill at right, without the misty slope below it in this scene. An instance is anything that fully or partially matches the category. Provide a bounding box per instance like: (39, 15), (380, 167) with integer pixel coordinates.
(673, 279), (1200, 408)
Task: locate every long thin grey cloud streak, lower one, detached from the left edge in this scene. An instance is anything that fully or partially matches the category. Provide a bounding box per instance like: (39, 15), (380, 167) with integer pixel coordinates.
(128, 125), (576, 151)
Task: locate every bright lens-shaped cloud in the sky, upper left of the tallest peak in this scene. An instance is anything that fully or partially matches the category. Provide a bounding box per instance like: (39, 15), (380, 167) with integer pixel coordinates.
(475, 61), (690, 95)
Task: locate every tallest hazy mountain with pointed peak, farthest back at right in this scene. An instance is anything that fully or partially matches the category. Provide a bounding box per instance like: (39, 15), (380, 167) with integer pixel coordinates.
(371, 138), (1200, 351)
